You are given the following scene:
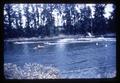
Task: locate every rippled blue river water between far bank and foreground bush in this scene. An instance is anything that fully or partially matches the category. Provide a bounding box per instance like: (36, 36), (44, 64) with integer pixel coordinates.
(4, 39), (116, 78)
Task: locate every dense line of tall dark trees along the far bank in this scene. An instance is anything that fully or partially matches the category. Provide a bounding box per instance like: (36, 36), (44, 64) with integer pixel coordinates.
(4, 4), (115, 38)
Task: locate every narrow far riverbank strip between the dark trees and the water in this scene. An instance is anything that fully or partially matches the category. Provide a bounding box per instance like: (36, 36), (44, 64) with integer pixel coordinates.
(4, 34), (116, 42)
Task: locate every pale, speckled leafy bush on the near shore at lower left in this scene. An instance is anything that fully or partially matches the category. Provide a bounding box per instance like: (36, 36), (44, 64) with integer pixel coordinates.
(4, 63), (59, 79)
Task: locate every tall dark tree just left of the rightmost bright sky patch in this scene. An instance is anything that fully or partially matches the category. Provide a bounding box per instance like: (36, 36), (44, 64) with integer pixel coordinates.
(93, 4), (106, 35)
